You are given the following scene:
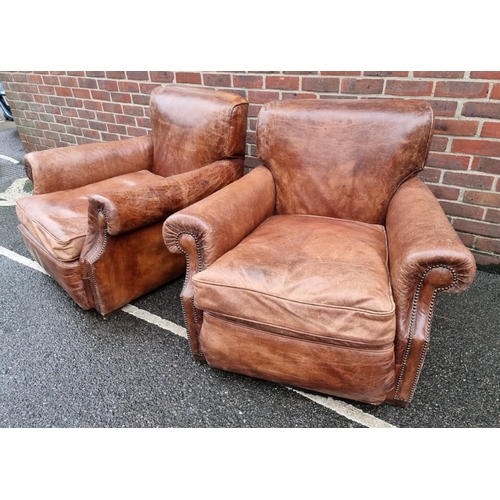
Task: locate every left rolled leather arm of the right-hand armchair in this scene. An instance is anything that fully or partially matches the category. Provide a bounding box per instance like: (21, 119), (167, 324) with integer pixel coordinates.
(163, 166), (275, 271)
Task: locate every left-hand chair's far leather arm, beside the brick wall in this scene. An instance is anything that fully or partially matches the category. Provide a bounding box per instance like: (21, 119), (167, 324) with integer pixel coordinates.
(24, 136), (153, 194)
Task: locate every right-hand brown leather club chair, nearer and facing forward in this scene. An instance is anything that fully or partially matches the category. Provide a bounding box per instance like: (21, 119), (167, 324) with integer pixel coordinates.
(163, 99), (475, 406)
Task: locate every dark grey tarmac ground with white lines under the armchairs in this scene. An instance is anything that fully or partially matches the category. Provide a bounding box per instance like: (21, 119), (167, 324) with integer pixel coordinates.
(0, 123), (500, 430)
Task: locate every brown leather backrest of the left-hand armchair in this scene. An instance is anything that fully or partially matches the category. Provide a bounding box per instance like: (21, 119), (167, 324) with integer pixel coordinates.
(150, 85), (248, 177)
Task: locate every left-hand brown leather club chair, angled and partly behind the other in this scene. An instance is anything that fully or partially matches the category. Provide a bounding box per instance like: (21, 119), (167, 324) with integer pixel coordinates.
(16, 85), (248, 315)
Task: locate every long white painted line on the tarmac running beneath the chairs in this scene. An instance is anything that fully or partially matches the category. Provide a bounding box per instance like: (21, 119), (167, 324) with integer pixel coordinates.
(0, 246), (395, 428)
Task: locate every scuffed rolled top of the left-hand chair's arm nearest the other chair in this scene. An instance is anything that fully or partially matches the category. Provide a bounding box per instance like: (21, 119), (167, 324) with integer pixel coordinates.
(89, 158), (243, 235)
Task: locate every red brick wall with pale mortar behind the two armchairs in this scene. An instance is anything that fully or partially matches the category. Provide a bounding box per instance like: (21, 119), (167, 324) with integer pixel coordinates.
(0, 71), (500, 265)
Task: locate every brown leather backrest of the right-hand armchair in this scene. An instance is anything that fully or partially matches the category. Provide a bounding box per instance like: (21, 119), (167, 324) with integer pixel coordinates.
(257, 99), (434, 224)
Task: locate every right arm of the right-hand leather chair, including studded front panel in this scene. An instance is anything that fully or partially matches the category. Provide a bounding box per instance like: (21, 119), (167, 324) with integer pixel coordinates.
(386, 177), (476, 406)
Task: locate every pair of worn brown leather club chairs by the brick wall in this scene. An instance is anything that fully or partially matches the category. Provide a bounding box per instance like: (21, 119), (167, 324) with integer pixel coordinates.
(18, 87), (475, 406)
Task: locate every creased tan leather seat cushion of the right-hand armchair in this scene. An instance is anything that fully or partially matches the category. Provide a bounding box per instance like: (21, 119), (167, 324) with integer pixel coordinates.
(193, 215), (395, 349)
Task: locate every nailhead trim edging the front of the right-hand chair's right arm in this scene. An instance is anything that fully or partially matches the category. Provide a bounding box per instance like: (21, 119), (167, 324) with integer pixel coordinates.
(394, 264), (458, 403)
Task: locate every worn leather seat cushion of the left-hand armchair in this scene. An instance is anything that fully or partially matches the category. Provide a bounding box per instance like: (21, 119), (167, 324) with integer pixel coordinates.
(16, 170), (163, 262)
